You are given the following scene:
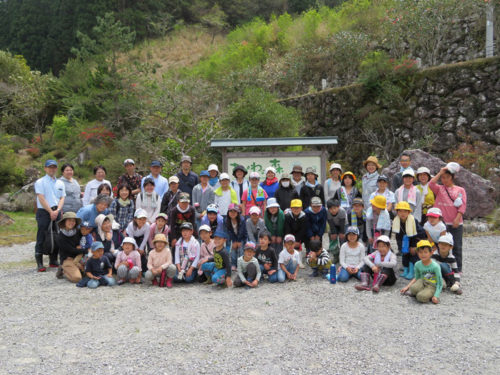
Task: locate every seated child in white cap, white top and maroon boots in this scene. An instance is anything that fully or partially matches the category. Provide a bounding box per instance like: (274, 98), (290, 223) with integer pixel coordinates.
(355, 235), (398, 293)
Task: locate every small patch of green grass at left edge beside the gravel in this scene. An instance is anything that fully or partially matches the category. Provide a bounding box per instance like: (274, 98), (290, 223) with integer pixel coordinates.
(0, 212), (37, 246)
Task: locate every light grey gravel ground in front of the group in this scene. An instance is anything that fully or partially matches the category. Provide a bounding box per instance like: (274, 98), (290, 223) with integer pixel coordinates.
(0, 237), (500, 374)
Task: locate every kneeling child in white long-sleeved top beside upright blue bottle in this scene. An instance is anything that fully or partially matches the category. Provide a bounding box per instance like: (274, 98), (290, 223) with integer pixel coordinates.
(337, 227), (365, 283)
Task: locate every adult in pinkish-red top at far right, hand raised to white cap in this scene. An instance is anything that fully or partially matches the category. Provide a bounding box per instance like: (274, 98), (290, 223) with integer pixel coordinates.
(429, 163), (467, 272)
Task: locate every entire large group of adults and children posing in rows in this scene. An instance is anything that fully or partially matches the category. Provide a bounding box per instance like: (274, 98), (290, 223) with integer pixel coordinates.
(35, 153), (467, 303)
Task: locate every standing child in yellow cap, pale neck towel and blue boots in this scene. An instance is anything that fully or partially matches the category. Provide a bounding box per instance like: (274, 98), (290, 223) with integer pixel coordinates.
(392, 202), (422, 280)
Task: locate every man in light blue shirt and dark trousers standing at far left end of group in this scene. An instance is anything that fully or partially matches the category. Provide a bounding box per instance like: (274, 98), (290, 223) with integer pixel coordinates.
(35, 159), (66, 272)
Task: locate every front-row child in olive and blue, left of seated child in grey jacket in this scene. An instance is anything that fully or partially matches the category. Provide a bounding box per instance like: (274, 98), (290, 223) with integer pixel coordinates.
(201, 231), (233, 287)
